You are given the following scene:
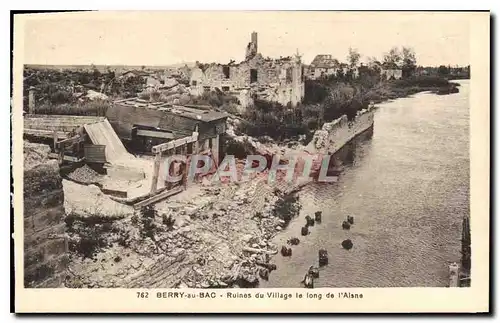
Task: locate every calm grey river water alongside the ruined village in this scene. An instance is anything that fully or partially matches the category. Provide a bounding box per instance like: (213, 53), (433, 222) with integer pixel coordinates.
(260, 80), (469, 288)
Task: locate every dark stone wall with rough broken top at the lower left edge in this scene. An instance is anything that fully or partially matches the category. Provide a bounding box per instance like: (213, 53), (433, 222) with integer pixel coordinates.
(23, 142), (68, 287)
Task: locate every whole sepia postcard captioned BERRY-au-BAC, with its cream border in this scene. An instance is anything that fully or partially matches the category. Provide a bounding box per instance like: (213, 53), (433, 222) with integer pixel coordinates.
(12, 11), (490, 313)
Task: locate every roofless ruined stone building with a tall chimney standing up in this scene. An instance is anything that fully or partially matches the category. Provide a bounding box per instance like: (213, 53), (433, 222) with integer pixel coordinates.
(190, 32), (304, 106)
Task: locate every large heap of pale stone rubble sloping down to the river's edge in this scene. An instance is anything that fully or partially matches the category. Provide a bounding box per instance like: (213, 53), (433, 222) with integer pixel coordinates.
(63, 173), (290, 288)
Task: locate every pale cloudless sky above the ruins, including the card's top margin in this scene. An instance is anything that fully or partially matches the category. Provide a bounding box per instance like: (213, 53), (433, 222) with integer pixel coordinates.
(20, 11), (470, 66)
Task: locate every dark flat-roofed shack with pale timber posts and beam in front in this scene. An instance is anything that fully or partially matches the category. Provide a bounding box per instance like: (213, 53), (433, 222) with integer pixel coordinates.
(106, 99), (228, 197)
